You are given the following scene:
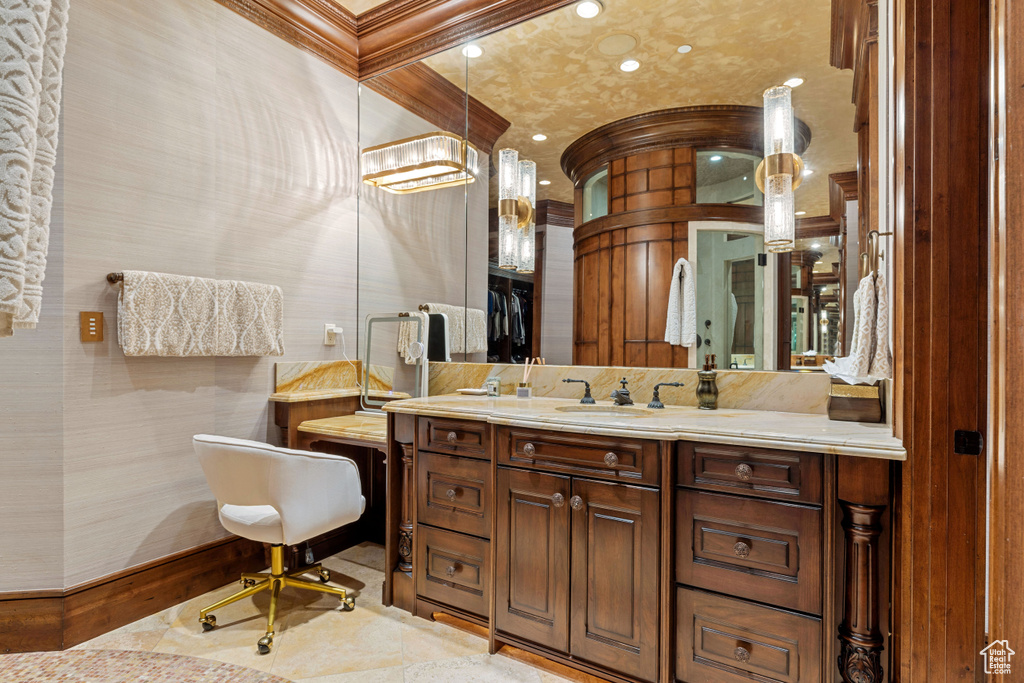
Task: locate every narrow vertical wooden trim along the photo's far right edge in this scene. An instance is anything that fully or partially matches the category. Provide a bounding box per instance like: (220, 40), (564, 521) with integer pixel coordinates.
(982, 0), (1024, 681)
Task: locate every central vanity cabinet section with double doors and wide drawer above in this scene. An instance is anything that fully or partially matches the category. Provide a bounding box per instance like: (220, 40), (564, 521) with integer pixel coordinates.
(495, 430), (660, 681)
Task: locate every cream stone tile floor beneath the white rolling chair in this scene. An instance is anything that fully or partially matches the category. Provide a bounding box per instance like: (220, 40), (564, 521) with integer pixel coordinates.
(77, 544), (596, 683)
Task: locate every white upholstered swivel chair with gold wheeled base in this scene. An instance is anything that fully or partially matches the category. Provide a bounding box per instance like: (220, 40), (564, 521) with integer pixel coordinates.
(193, 434), (366, 654)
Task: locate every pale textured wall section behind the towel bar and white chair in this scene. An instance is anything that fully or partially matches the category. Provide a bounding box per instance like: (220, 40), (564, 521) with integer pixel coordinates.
(56, 0), (356, 587)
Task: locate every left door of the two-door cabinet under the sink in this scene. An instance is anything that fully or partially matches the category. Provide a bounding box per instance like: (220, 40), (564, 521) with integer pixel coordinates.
(495, 468), (570, 652)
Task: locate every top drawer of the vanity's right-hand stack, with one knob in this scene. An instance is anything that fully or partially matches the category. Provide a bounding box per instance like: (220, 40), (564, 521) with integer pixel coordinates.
(676, 442), (821, 505)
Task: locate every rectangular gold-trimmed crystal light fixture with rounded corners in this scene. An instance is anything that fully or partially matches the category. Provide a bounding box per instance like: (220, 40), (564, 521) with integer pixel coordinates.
(360, 131), (479, 195)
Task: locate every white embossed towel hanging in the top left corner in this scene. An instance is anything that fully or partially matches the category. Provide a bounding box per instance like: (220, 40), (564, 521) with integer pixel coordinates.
(0, 0), (68, 337)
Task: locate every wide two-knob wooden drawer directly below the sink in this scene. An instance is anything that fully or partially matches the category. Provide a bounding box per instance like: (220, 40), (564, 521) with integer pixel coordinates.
(498, 427), (658, 484)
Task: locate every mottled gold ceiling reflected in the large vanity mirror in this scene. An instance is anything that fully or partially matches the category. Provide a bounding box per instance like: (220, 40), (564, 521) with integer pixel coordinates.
(426, 0), (857, 216)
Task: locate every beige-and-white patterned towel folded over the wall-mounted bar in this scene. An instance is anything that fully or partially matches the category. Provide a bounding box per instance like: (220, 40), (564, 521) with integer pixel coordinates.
(118, 270), (285, 356)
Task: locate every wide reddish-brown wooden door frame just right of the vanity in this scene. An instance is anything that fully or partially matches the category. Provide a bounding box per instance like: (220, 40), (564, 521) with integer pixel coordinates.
(892, 0), (987, 683)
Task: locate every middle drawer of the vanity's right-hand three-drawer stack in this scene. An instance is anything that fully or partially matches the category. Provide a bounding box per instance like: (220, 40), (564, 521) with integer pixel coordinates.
(676, 490), (822, 614)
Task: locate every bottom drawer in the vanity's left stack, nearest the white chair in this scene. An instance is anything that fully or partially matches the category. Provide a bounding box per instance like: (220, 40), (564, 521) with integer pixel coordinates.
(413, 525), (490, 617)
